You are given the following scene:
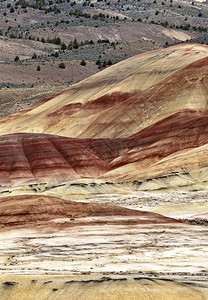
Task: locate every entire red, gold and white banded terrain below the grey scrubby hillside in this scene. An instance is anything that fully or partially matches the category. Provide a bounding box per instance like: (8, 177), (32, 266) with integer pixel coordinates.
(0, 44), (208, 300)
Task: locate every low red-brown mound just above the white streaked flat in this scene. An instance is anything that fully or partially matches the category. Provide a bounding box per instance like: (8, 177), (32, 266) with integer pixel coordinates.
(0, 195), (178, 228)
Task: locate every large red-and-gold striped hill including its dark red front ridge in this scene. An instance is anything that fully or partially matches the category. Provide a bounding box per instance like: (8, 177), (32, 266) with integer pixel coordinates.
(0, 44), (208, 190)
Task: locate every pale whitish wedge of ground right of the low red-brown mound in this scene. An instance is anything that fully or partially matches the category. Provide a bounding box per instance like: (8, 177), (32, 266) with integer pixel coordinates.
(83, 191), (208, 224)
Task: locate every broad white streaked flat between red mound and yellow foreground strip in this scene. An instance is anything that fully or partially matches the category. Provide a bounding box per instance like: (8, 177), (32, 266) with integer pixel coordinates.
(0, 224), (208, 283)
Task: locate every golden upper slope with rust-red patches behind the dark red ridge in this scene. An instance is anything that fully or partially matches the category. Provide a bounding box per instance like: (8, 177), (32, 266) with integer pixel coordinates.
(0, 44), (208, 138)
